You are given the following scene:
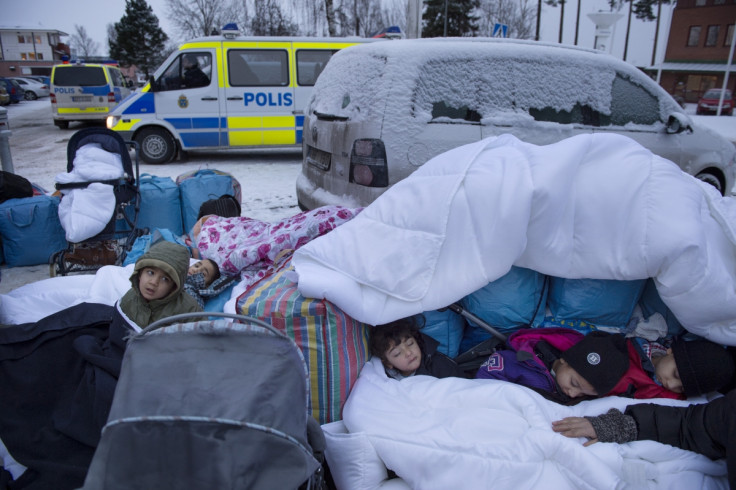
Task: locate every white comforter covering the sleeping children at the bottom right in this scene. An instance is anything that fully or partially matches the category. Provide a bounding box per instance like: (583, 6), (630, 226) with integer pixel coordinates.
(344, 358), (728, 490)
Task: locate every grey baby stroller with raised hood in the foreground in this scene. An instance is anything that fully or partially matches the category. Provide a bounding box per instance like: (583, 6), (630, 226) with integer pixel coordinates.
(78, 313), (326, 490)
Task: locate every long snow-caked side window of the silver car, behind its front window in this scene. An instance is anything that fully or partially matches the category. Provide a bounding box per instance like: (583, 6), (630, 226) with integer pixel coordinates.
(412, 56), (615, 125)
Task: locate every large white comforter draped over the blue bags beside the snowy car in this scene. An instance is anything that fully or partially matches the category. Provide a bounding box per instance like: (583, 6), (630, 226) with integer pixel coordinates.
(294, 134), (736, 345)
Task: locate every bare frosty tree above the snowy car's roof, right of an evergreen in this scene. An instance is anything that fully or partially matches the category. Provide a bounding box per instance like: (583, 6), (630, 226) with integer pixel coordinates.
(478, 0), (537, 39)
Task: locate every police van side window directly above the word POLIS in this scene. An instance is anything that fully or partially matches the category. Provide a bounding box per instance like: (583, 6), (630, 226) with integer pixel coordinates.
(227, 49), (289, 87)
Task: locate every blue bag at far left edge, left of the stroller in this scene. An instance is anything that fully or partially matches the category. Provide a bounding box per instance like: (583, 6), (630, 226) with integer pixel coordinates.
(0, 194), (67, 267)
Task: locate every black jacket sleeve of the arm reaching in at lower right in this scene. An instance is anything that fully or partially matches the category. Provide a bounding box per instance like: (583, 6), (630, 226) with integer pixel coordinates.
(624, 389), (736, 490)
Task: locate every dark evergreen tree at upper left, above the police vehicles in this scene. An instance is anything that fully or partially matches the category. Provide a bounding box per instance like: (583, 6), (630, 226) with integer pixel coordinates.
(108, 0), (169, 78)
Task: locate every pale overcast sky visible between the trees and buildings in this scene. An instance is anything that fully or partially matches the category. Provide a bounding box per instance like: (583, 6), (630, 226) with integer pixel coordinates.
(0, 0), (672, 65)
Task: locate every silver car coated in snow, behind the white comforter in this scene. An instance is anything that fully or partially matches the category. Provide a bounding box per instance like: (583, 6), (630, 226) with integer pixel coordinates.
(296, 38), (736, 209)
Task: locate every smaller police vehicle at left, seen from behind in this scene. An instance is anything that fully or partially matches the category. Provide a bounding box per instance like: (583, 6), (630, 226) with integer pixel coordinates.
(50, 62), (130, 129)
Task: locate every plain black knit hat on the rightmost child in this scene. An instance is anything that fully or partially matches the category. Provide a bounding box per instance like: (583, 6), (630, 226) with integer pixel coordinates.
(672, 339), (735, 398)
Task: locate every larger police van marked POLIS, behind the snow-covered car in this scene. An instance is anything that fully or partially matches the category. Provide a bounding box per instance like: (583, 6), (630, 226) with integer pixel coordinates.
(107, 26), (385, 163)
